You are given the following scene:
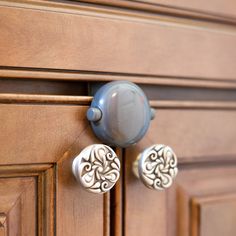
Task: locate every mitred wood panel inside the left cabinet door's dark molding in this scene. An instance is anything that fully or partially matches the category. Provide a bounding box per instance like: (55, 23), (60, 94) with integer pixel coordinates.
(0, 177), (37, 236)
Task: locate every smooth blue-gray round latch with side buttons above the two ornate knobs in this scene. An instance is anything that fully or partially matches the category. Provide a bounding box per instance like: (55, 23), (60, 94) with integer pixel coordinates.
(87, 81), (154, 147)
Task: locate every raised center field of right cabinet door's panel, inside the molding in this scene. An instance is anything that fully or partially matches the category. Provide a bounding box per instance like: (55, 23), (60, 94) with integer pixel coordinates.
(191, 194), (236, 236)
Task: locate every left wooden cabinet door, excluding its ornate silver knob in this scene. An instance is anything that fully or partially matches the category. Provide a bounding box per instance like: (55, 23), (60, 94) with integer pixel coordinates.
(0, 100), (109, 236)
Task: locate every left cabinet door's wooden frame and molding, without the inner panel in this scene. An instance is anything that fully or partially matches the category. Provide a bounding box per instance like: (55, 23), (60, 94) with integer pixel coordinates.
(0, 104), (106, 236)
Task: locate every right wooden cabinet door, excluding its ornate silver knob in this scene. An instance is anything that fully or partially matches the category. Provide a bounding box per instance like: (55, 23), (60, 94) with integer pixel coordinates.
(124, 107), (236, 236)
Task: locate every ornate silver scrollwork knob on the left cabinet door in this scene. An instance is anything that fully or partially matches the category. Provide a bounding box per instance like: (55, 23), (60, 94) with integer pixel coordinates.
(72, 144), (120, 193)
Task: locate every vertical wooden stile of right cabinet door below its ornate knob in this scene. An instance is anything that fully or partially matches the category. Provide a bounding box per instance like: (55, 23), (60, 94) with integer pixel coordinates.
(124, 148), (169, 236)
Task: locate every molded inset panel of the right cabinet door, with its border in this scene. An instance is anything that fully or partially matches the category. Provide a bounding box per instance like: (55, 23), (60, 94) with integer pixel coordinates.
(175, 163), (236, 236)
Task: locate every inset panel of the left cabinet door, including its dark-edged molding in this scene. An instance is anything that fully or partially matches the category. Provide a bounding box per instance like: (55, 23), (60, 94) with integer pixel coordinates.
(0, 164), (55, 236)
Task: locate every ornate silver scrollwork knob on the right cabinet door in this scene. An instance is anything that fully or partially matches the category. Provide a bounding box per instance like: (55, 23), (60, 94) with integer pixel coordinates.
(133, 144), (178, 190)
